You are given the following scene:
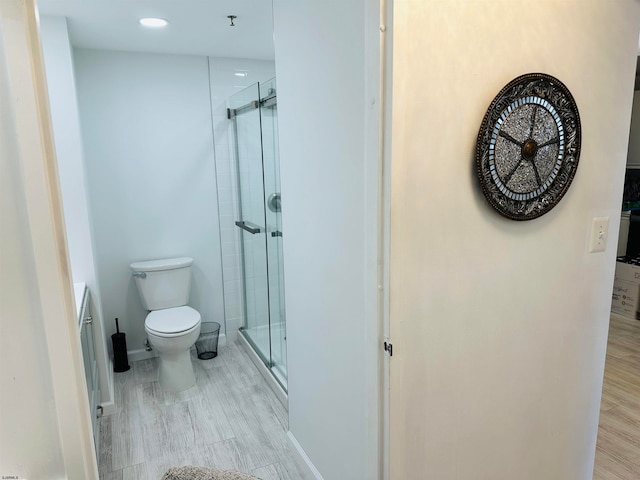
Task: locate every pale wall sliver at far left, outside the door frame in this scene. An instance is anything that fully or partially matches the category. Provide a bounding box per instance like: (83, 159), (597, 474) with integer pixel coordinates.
(0, 16), (64, 478)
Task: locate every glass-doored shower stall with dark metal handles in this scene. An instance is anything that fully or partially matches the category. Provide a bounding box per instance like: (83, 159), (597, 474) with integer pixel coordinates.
(228, 79), (287, 391)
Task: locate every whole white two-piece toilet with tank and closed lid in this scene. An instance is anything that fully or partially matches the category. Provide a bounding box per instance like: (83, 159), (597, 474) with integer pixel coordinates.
(130, 257), (201, 392)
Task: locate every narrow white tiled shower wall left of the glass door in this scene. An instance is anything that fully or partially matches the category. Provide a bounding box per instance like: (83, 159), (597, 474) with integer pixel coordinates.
(209, 57), (275, 340)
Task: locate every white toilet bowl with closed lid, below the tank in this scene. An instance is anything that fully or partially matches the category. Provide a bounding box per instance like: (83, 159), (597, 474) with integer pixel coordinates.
(144, 306), (201, 392)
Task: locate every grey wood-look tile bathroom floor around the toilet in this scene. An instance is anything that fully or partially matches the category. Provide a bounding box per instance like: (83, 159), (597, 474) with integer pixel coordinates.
(99, 343), (313, 480)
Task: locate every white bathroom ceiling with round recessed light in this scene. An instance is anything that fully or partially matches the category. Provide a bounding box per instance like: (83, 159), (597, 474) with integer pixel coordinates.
(37, 0), (274, 60)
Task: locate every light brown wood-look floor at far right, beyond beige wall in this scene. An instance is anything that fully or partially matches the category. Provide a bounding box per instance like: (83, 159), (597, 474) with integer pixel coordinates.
(593, 315), (640, 480)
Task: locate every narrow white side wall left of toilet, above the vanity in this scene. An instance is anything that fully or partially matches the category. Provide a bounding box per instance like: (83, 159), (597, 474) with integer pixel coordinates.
(40, 17), (113, 411)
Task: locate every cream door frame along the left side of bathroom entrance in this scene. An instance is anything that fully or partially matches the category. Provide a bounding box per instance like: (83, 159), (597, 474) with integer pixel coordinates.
(0, 0), (98, 480)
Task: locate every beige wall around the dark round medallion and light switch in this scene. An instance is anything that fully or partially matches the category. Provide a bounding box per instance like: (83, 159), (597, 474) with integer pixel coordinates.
(391, 0), (640, 480)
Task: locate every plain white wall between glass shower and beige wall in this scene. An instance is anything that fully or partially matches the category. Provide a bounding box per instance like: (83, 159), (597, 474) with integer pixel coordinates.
(274, 0), (380, 480)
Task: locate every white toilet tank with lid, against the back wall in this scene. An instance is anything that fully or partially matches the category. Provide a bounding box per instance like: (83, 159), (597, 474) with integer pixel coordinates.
(130, 257), (193, 310)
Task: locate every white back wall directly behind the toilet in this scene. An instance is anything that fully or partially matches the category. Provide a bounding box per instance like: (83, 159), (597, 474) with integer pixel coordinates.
(75, 49), (224, 350)
